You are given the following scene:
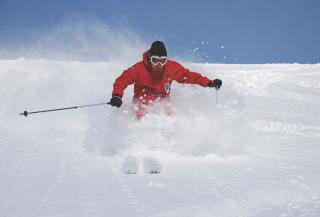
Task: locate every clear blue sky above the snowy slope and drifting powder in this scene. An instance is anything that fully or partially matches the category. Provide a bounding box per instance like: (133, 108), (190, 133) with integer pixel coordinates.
(0, 0), (320, 63)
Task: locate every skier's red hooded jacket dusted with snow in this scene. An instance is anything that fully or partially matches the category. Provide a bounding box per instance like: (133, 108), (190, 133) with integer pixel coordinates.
(112, 51), (210, 104)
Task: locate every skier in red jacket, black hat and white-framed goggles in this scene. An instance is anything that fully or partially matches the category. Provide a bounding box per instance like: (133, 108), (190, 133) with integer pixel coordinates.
(108, 41), (222, 119)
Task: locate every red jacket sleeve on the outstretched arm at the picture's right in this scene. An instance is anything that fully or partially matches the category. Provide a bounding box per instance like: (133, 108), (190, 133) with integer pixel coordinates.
(174, 64), (210, 87)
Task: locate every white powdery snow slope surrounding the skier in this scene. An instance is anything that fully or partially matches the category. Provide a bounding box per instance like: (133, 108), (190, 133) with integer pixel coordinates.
(0, 58), (320, 217)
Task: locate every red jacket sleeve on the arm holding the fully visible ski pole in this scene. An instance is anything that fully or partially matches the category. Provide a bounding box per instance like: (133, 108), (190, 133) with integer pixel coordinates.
(112, 66), (138, 96)
